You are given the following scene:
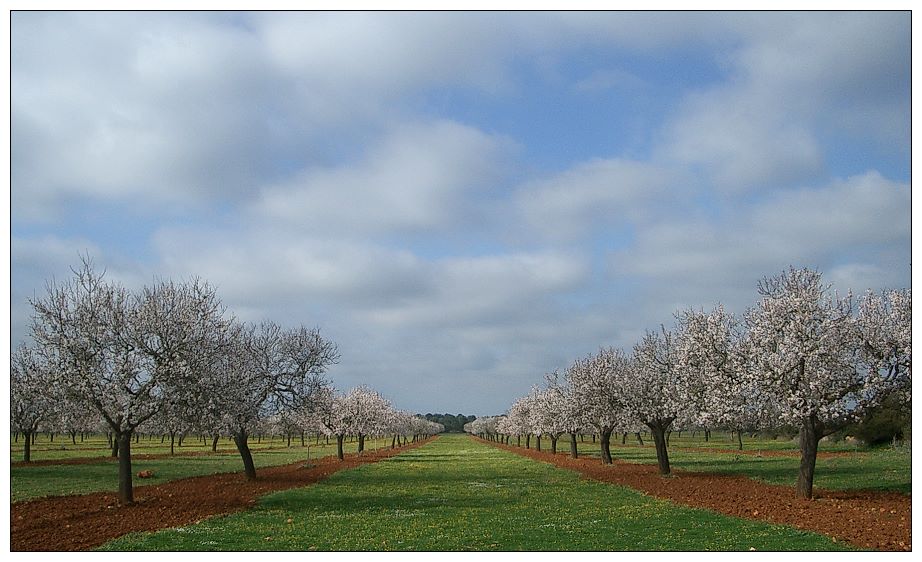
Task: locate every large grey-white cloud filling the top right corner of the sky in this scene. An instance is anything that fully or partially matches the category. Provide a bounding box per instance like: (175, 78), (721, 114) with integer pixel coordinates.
(660, 13), (909, 193)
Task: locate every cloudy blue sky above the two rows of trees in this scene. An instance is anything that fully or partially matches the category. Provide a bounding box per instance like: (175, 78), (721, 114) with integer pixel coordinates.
(11, 12), (911, 414)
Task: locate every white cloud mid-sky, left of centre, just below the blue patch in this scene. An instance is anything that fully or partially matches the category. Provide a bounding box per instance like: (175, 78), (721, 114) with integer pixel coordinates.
(255, 121), (514, 236)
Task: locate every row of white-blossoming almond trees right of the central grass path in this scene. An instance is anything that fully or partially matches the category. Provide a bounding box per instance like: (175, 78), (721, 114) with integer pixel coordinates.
(466, 268), (912, 498)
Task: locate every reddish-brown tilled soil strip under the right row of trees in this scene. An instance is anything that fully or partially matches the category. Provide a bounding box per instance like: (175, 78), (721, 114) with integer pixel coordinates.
(481, 440), (912, 551)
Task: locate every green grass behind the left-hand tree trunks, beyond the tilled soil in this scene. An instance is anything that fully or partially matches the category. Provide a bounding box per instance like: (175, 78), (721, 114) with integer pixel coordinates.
(10, 439), (390, 502)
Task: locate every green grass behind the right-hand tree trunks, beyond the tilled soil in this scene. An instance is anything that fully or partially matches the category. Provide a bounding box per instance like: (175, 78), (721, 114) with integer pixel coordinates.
(556, 436), (912, 494)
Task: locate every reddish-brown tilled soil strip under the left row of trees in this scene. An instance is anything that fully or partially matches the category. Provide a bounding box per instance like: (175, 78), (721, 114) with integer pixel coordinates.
(10, 441), (427, 551)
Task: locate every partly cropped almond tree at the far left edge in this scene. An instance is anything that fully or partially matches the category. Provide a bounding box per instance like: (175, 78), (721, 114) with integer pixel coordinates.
(10, 345), (58, 462)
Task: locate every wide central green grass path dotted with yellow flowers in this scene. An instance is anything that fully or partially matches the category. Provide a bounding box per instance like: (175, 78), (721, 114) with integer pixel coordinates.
(103, 436), (844, 551)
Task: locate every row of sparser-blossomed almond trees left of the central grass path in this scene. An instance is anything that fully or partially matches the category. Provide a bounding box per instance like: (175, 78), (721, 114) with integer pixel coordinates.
(10, 258), (437, 504)
